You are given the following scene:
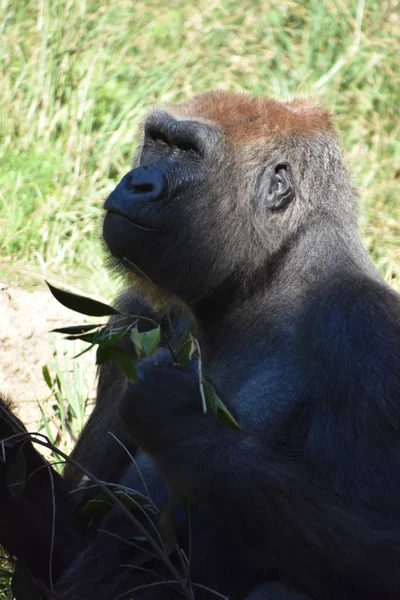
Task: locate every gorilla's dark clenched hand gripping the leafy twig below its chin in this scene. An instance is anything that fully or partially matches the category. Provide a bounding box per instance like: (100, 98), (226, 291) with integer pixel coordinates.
(118, 349), (208, 456)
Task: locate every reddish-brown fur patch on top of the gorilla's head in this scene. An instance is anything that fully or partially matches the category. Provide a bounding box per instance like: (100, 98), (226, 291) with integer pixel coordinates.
(171, 92), (334, 145)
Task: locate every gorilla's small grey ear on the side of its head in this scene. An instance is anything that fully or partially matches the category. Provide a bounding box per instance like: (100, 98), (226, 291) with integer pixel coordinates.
(263, 160), (295, 210)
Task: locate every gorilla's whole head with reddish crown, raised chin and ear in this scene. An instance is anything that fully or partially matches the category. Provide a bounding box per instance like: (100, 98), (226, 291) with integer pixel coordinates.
(103, 93), (344, 304)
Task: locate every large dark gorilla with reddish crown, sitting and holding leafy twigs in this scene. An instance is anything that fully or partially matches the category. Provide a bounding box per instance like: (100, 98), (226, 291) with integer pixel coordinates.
(0, 92), (400, 600)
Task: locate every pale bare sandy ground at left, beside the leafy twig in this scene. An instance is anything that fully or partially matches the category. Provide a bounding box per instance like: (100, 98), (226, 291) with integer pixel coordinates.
(0, 283), (95, 431)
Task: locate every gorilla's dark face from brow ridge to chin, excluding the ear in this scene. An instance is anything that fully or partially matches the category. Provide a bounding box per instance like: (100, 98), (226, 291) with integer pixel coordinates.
(103, 112), (248, 302)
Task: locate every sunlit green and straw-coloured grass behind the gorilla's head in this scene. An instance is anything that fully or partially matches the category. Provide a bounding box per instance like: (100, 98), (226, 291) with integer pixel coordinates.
(0, 0), (400, 297)
